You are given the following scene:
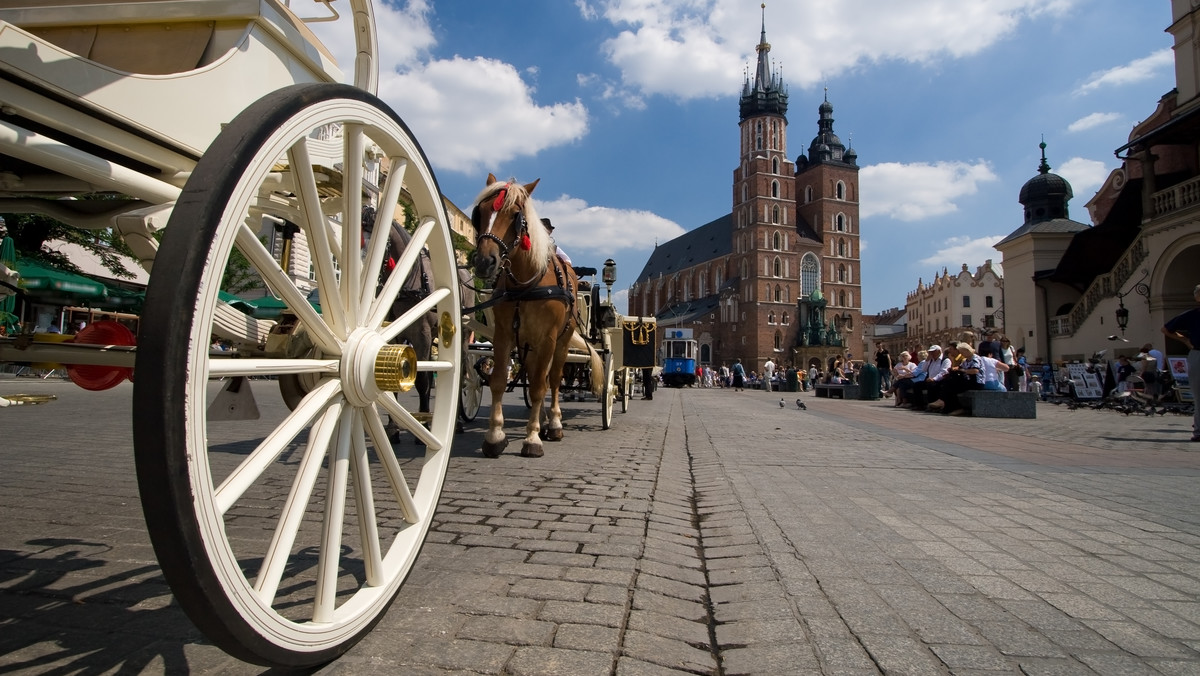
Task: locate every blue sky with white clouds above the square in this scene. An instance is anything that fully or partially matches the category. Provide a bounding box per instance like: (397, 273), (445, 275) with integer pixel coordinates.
(307, 0), (1175, 312)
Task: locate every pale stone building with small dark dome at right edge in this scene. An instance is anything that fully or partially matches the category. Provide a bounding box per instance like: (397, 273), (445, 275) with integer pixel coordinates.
(996, 0), (1200, 367)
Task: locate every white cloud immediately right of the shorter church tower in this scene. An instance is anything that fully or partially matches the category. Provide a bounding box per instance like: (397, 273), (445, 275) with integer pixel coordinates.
(858, 160), (996, 221)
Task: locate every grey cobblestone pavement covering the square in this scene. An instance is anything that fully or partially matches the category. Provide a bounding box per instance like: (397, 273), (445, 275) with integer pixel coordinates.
(0, 379), (1200, 675)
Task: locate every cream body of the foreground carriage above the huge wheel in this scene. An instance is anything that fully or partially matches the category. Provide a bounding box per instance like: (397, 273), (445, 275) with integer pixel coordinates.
(0, 0), (342, 171)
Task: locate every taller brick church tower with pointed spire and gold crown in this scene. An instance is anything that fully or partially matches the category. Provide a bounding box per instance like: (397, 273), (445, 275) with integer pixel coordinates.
(726, 8), (798, 369)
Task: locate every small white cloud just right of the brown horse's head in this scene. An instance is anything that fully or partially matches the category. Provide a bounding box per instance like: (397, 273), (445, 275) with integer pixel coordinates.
(535, 195), (685, 258)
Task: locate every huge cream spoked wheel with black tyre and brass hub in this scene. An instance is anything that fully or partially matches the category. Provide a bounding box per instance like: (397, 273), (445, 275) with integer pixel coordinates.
(134, 84), (461, 666)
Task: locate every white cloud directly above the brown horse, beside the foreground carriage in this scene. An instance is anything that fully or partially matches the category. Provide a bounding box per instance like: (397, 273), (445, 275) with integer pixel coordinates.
(314, 0), (588, 178)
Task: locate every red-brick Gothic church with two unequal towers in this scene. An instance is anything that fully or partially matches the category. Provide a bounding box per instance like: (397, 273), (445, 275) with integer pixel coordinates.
(629, 9), (863, 370)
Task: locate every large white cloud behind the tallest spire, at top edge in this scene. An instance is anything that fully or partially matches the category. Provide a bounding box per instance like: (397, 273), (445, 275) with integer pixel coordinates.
(590, 0), (1080, 98)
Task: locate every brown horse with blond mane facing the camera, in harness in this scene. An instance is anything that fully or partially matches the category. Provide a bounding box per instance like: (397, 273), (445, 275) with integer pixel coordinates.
(472, 174), (605, 457)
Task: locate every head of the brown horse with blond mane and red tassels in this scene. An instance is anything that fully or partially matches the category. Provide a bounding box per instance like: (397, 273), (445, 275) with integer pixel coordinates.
(470, 174), (553, 283)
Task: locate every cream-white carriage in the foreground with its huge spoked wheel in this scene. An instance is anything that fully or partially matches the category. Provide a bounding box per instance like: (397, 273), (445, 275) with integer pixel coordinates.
(0, 0), (461, 666)
